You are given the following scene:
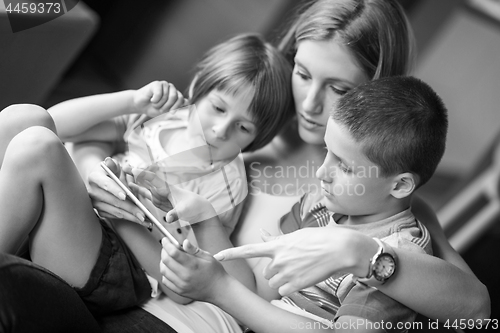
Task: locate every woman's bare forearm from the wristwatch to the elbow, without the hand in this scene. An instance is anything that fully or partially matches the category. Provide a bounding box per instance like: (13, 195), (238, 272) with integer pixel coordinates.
(377, 248), (490, 321)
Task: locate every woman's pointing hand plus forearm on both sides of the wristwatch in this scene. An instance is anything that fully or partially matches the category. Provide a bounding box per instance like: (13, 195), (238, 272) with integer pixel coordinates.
(215, 217), (490, 320)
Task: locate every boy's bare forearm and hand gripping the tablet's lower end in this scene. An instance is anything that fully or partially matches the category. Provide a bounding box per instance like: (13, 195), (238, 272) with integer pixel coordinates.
(160, 238), (376, 333)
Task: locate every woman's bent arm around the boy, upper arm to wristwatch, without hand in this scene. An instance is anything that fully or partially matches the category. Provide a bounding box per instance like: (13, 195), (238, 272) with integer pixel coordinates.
(388, 197), (490, 320)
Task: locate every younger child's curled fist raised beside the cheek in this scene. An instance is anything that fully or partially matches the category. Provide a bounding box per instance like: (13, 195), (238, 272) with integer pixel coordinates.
(133, 81), (187, 118)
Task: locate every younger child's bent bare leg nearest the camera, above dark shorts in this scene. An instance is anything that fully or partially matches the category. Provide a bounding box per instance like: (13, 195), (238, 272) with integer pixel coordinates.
(0, 126), (102, 287)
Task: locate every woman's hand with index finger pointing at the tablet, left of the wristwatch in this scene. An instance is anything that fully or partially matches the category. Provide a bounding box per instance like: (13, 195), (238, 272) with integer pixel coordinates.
(214, 227), (378, 295)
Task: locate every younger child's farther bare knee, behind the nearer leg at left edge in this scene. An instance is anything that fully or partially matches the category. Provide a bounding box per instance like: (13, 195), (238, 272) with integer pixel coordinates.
(0, 104), (56, 136)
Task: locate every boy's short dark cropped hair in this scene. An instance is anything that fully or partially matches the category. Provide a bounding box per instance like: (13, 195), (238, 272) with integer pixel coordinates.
(332, 76), (448, 186)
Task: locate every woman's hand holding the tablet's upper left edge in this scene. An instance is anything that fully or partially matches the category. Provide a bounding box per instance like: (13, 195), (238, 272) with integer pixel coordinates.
(88, 158), (149, 226)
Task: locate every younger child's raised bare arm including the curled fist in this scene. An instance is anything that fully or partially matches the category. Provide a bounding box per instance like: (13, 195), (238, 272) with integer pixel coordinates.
(48, 81), (186, 141)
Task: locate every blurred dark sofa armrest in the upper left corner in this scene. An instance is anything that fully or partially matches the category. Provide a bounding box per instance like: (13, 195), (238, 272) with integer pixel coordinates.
(0, 1), (99, 110)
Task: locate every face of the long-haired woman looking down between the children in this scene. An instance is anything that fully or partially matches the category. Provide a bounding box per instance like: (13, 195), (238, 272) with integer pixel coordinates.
(292, 40), (369, 145)
